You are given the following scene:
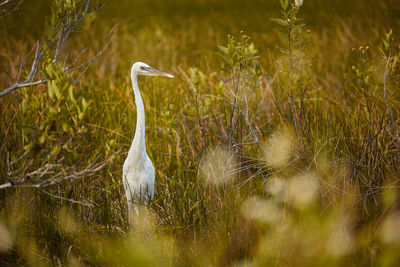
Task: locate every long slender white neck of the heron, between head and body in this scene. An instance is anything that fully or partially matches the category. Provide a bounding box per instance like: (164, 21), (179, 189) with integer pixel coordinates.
(131, 75), (146, 155)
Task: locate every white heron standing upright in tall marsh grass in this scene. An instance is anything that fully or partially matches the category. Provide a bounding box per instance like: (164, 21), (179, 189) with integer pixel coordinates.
(122, 62), (174, 215)
